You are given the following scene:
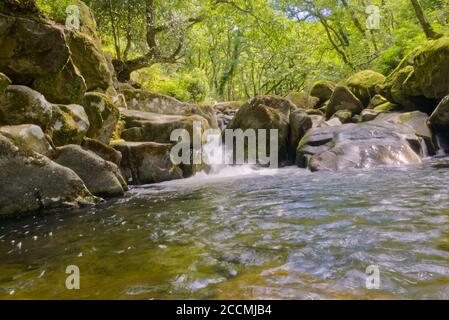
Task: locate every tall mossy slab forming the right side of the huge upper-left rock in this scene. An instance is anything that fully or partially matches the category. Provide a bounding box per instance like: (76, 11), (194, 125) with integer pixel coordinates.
(67, 30), (113, 91)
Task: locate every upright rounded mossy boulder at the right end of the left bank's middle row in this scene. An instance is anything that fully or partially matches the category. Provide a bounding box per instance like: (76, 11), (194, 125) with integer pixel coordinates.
(84, 92), (120, 144)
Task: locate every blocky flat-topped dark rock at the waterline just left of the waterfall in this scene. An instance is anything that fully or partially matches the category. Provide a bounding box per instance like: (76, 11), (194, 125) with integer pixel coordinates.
(112, 142), (183, 185)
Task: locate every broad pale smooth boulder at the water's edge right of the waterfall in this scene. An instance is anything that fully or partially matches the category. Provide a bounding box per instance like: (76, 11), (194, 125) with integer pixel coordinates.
(297, 115), (427, 171)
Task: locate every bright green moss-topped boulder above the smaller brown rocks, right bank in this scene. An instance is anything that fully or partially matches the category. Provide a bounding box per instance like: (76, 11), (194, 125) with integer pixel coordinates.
(342, 70), (386, 106)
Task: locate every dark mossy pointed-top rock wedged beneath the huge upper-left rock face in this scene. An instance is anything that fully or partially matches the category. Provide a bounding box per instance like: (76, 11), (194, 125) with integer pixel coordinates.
(32, 59), (87, 104)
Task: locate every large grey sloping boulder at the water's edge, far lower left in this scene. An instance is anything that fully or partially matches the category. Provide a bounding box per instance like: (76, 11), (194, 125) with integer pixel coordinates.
(0, 135), (98, 216)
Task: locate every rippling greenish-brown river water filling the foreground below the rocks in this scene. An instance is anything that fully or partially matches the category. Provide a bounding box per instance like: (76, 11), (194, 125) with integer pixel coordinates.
(0, 159), (449, 299)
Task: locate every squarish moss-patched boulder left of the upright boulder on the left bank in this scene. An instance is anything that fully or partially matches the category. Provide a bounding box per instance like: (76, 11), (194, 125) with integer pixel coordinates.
(51, 104), (90, 147)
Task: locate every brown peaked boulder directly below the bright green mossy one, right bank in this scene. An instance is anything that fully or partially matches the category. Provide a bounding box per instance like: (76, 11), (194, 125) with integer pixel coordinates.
(326, 86), (363, 119)
